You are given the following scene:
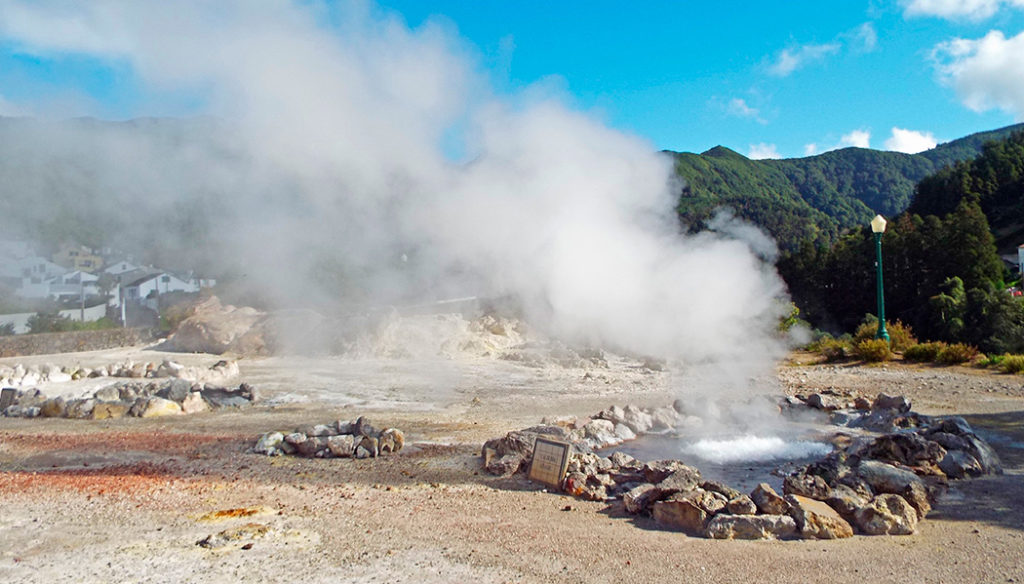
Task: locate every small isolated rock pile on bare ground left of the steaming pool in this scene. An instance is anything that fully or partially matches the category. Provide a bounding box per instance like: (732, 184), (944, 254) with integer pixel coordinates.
(253, 416), (406, 458)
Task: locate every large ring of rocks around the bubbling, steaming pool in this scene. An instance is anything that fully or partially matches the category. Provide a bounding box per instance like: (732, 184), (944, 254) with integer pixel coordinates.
(482, 394), (1002, 539)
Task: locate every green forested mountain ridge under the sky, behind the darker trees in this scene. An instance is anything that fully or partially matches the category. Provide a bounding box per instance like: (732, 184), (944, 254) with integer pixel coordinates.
(668, 124), (1024, 251)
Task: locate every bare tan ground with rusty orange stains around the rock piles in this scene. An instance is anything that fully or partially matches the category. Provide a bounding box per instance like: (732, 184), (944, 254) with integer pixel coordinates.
(0, 351), (1024, 583)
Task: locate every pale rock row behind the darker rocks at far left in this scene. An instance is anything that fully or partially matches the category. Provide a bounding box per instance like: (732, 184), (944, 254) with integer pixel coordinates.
(0, 360), (239, 387)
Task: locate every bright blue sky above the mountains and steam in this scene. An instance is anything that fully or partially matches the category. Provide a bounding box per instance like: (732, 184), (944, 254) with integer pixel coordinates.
(0, 0), (1024, 157)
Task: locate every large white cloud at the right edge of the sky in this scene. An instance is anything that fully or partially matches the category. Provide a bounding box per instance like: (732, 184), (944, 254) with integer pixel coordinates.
(932, 31), (1024, 120)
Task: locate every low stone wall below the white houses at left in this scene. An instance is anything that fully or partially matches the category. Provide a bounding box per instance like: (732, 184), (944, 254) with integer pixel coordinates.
(0, 329), (160, 357)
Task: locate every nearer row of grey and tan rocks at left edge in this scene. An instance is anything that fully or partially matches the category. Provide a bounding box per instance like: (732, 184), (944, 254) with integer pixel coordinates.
(0, 378), (259, 420)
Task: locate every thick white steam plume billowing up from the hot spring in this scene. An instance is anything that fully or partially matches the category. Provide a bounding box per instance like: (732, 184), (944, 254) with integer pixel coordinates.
(0, 0), (784, 377)
